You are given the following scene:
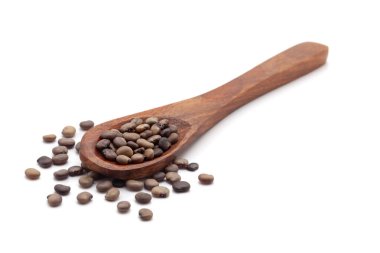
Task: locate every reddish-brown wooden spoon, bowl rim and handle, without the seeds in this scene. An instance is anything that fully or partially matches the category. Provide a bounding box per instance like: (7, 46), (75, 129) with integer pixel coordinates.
(80, 42), (328, 179)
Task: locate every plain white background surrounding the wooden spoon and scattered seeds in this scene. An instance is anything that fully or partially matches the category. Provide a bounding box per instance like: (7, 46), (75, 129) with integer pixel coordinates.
(0, 0), (380, 253)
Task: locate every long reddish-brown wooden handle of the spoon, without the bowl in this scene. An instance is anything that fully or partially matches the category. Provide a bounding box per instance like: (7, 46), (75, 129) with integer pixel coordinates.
(174, 42), (328, 135)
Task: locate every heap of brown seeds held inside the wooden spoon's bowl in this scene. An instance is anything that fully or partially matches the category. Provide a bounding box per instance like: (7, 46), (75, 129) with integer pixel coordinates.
(96, 117), (179, 164)
